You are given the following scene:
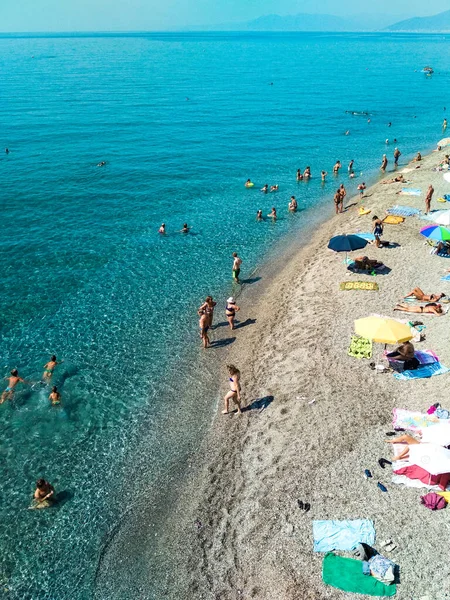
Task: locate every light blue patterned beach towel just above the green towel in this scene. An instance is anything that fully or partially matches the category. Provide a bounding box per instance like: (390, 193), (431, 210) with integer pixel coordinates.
(313, 519), (375, 552)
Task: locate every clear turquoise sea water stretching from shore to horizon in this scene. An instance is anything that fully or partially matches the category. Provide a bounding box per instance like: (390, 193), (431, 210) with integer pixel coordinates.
(0, 34), (450, 600)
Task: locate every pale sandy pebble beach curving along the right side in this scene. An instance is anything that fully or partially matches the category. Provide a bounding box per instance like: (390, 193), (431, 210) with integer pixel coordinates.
(163, 146), (450, 600)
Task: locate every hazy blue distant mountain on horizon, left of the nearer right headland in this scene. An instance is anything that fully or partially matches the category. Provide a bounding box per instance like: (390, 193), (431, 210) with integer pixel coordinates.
(189, 13), (395, 32)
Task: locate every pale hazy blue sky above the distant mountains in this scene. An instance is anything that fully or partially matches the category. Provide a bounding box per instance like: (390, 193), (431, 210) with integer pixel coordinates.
(0, 0), (449, 32)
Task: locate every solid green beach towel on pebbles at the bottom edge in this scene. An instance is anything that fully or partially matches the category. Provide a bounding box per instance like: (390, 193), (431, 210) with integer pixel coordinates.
(322, 552), (397, 596)
